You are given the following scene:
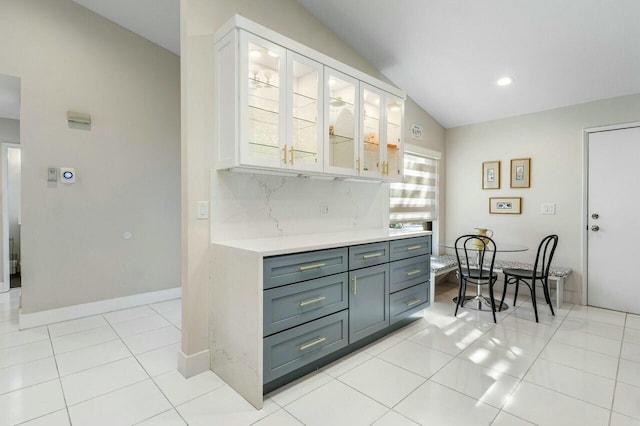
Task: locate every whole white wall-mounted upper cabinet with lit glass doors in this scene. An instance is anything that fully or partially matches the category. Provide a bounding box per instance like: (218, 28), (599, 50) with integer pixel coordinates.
(215, 15), (404, 181)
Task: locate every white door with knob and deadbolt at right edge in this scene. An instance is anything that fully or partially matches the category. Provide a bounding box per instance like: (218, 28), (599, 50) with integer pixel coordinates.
(587, 127), (640, 314)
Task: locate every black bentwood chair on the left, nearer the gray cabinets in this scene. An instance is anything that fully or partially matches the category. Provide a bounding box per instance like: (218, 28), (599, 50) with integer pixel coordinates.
(455, 235), (498, 322)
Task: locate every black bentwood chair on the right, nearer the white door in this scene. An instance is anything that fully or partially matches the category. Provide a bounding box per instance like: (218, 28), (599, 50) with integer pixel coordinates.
(500, 235), (558, 322)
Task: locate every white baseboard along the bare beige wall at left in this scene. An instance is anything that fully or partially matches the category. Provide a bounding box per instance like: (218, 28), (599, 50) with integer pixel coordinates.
(19, 287), (182, 330)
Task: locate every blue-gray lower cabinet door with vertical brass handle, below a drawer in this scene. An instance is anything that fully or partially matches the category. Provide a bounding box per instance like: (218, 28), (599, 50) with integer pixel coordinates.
(349, 264), (389, 343)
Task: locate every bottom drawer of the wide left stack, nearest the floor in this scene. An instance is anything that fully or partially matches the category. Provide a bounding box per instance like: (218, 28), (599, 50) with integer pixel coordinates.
(263, 311), (348, 383)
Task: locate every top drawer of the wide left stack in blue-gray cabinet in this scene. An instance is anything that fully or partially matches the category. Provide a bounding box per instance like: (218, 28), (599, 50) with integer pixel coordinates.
(263, 247), (348, 290)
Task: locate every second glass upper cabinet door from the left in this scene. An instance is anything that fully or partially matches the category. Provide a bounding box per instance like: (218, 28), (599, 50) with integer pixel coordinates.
(286, 51), (323, 171)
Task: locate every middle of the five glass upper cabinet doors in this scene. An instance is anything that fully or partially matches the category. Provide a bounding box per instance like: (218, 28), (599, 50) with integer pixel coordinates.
(324, 67), (359, 176)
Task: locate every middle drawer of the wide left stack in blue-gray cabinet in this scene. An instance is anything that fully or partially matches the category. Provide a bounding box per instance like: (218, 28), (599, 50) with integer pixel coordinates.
(264, 272), (349, 336)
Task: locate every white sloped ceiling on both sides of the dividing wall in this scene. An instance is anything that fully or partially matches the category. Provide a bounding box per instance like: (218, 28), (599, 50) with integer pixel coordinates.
(2, 0), (640, 127)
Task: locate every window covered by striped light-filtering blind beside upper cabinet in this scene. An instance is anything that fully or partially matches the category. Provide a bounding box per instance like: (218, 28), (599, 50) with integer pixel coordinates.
(389, 152), (438, 223)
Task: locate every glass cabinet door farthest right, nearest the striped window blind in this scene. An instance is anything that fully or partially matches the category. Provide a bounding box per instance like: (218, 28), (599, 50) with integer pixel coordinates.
(382, 94), (404, 181)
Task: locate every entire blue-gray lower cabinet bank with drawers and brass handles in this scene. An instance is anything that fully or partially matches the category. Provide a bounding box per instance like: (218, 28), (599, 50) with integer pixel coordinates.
(263, 236), (431, 389)
